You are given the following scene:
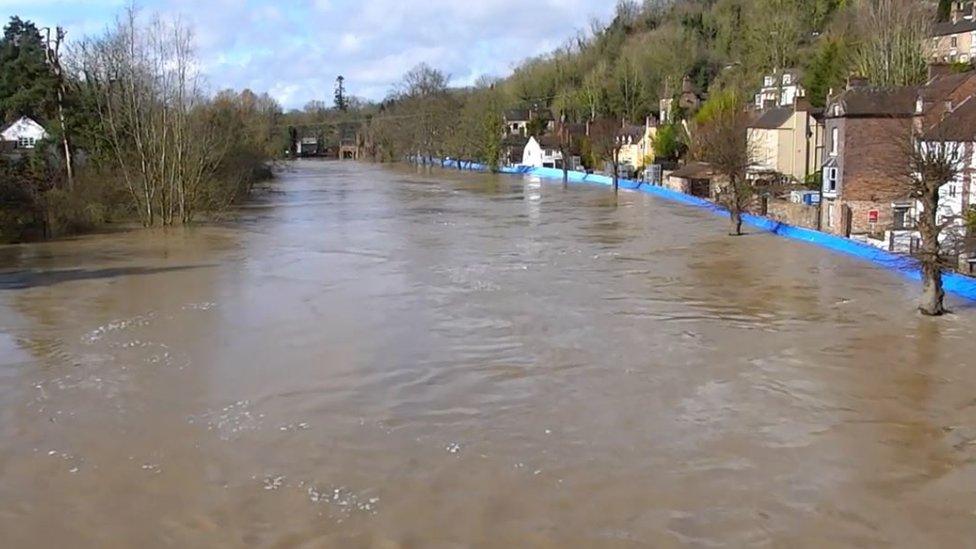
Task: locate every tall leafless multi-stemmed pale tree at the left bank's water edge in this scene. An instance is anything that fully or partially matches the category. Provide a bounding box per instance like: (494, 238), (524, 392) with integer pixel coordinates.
(77, 9), (227, 226)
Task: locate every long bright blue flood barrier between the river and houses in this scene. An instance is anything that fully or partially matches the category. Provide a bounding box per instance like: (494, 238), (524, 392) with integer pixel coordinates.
(418, 156), (976, 301)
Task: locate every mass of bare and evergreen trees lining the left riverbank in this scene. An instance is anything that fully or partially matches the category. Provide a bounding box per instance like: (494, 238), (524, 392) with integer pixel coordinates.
(0, 10), (282, 240)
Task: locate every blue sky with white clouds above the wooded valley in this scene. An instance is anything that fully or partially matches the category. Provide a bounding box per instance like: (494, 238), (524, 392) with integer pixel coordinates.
(0, 0), (615, 107)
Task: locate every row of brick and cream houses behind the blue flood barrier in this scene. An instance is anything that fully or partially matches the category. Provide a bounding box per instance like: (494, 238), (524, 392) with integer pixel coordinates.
(503, 66), (976, 272)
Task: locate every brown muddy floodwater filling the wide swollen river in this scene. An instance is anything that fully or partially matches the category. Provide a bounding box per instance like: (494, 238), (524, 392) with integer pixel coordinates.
(0, 163), (976, 549)
